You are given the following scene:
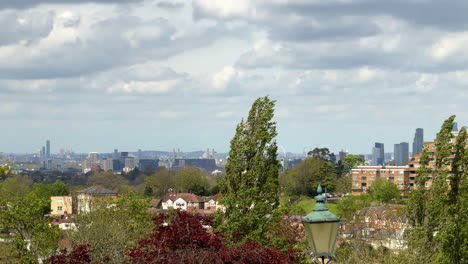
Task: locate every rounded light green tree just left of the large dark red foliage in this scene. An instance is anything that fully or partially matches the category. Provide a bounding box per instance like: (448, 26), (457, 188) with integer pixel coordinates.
(67, 195), (153, 263)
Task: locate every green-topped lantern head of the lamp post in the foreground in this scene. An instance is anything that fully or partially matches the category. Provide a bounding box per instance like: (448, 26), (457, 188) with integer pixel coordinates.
(302, 184), (340, 263)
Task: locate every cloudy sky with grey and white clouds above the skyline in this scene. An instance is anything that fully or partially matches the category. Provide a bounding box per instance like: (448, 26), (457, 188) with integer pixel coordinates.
(0, 0), (468, 153)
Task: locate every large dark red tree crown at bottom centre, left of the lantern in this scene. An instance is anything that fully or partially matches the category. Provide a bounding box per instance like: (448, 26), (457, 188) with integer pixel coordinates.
(129, 211), (300, 264)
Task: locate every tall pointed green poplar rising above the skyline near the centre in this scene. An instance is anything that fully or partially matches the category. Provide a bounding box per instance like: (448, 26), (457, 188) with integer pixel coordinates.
(217, 97), (281, 242)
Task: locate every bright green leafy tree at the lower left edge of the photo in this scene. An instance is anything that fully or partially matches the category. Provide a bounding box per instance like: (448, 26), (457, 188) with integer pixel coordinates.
(0, 177), (61, 263)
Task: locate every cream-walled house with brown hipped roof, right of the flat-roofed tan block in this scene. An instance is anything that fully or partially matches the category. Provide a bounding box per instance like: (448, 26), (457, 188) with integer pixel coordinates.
(76, 186), (118, 213)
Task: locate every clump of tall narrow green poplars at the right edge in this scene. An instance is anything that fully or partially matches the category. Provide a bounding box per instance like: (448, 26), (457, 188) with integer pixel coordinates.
(407, 116), (468, 264)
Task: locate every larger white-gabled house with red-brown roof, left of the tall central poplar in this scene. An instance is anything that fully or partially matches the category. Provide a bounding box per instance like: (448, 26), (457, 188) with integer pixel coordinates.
(161, 192), (204, 210)
